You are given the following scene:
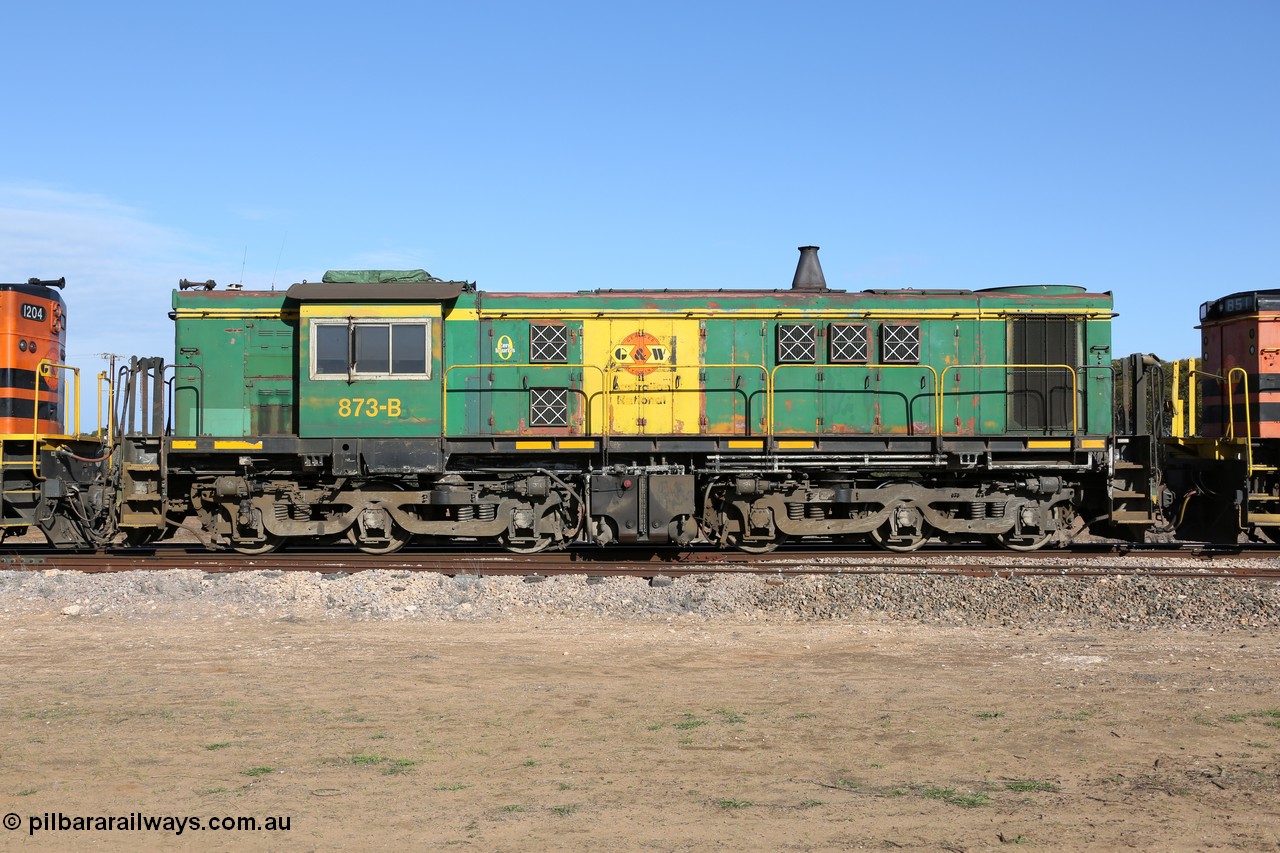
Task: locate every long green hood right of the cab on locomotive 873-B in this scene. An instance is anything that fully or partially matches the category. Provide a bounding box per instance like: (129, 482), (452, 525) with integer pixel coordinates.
(447, 286), (1112, 435)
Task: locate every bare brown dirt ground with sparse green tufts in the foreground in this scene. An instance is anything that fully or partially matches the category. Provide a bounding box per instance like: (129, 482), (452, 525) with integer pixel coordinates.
(0, 613), (1280, 850)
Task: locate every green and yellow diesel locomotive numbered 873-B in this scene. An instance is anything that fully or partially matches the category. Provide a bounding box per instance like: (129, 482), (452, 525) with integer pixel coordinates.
(118, 247), (1155, 553)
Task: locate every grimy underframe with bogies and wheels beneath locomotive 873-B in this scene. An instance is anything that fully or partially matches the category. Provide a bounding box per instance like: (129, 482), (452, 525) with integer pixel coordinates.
(122, 437), (1108, 553)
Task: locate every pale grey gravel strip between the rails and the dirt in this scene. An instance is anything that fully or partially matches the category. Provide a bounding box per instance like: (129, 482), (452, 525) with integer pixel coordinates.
(0, 561), (1280, 631)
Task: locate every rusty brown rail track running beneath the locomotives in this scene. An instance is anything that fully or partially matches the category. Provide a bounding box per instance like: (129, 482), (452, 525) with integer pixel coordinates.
(0, 544), (1280, 581)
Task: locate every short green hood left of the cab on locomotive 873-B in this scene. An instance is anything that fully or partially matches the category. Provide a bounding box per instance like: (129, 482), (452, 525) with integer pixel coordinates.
(173, 291), (297, 437)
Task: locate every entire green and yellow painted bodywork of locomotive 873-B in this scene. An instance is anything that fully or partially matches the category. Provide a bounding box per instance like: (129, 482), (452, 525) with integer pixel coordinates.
(173, 281), (1112, 438)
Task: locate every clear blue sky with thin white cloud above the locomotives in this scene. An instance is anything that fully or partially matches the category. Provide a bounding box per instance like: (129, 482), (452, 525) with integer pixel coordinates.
(0, 0), (1280, 371)
